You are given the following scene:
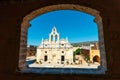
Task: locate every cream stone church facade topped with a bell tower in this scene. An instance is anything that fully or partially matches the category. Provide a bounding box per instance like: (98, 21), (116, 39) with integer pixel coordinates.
(36, 27), (73, 64)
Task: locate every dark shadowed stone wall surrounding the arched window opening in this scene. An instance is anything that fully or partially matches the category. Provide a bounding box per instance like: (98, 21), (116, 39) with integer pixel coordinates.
(0, 0), (120, 80)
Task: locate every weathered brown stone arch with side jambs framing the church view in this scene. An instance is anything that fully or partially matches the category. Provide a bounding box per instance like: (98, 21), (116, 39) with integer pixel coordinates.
(19, 4), (107, 70)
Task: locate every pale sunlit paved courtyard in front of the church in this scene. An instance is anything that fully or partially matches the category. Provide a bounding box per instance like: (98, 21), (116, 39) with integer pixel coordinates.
(27, 56), (99, 69)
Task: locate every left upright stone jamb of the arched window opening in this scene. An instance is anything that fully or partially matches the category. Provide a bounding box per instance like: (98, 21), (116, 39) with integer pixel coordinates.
(18, 23), (30, 70)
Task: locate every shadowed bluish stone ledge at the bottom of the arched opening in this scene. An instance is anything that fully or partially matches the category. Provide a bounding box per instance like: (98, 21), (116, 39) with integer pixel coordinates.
(18, 66), (106, 75)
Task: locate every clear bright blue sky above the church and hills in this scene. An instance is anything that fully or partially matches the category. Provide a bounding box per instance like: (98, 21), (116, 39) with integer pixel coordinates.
(27, 10), (98, 46)
